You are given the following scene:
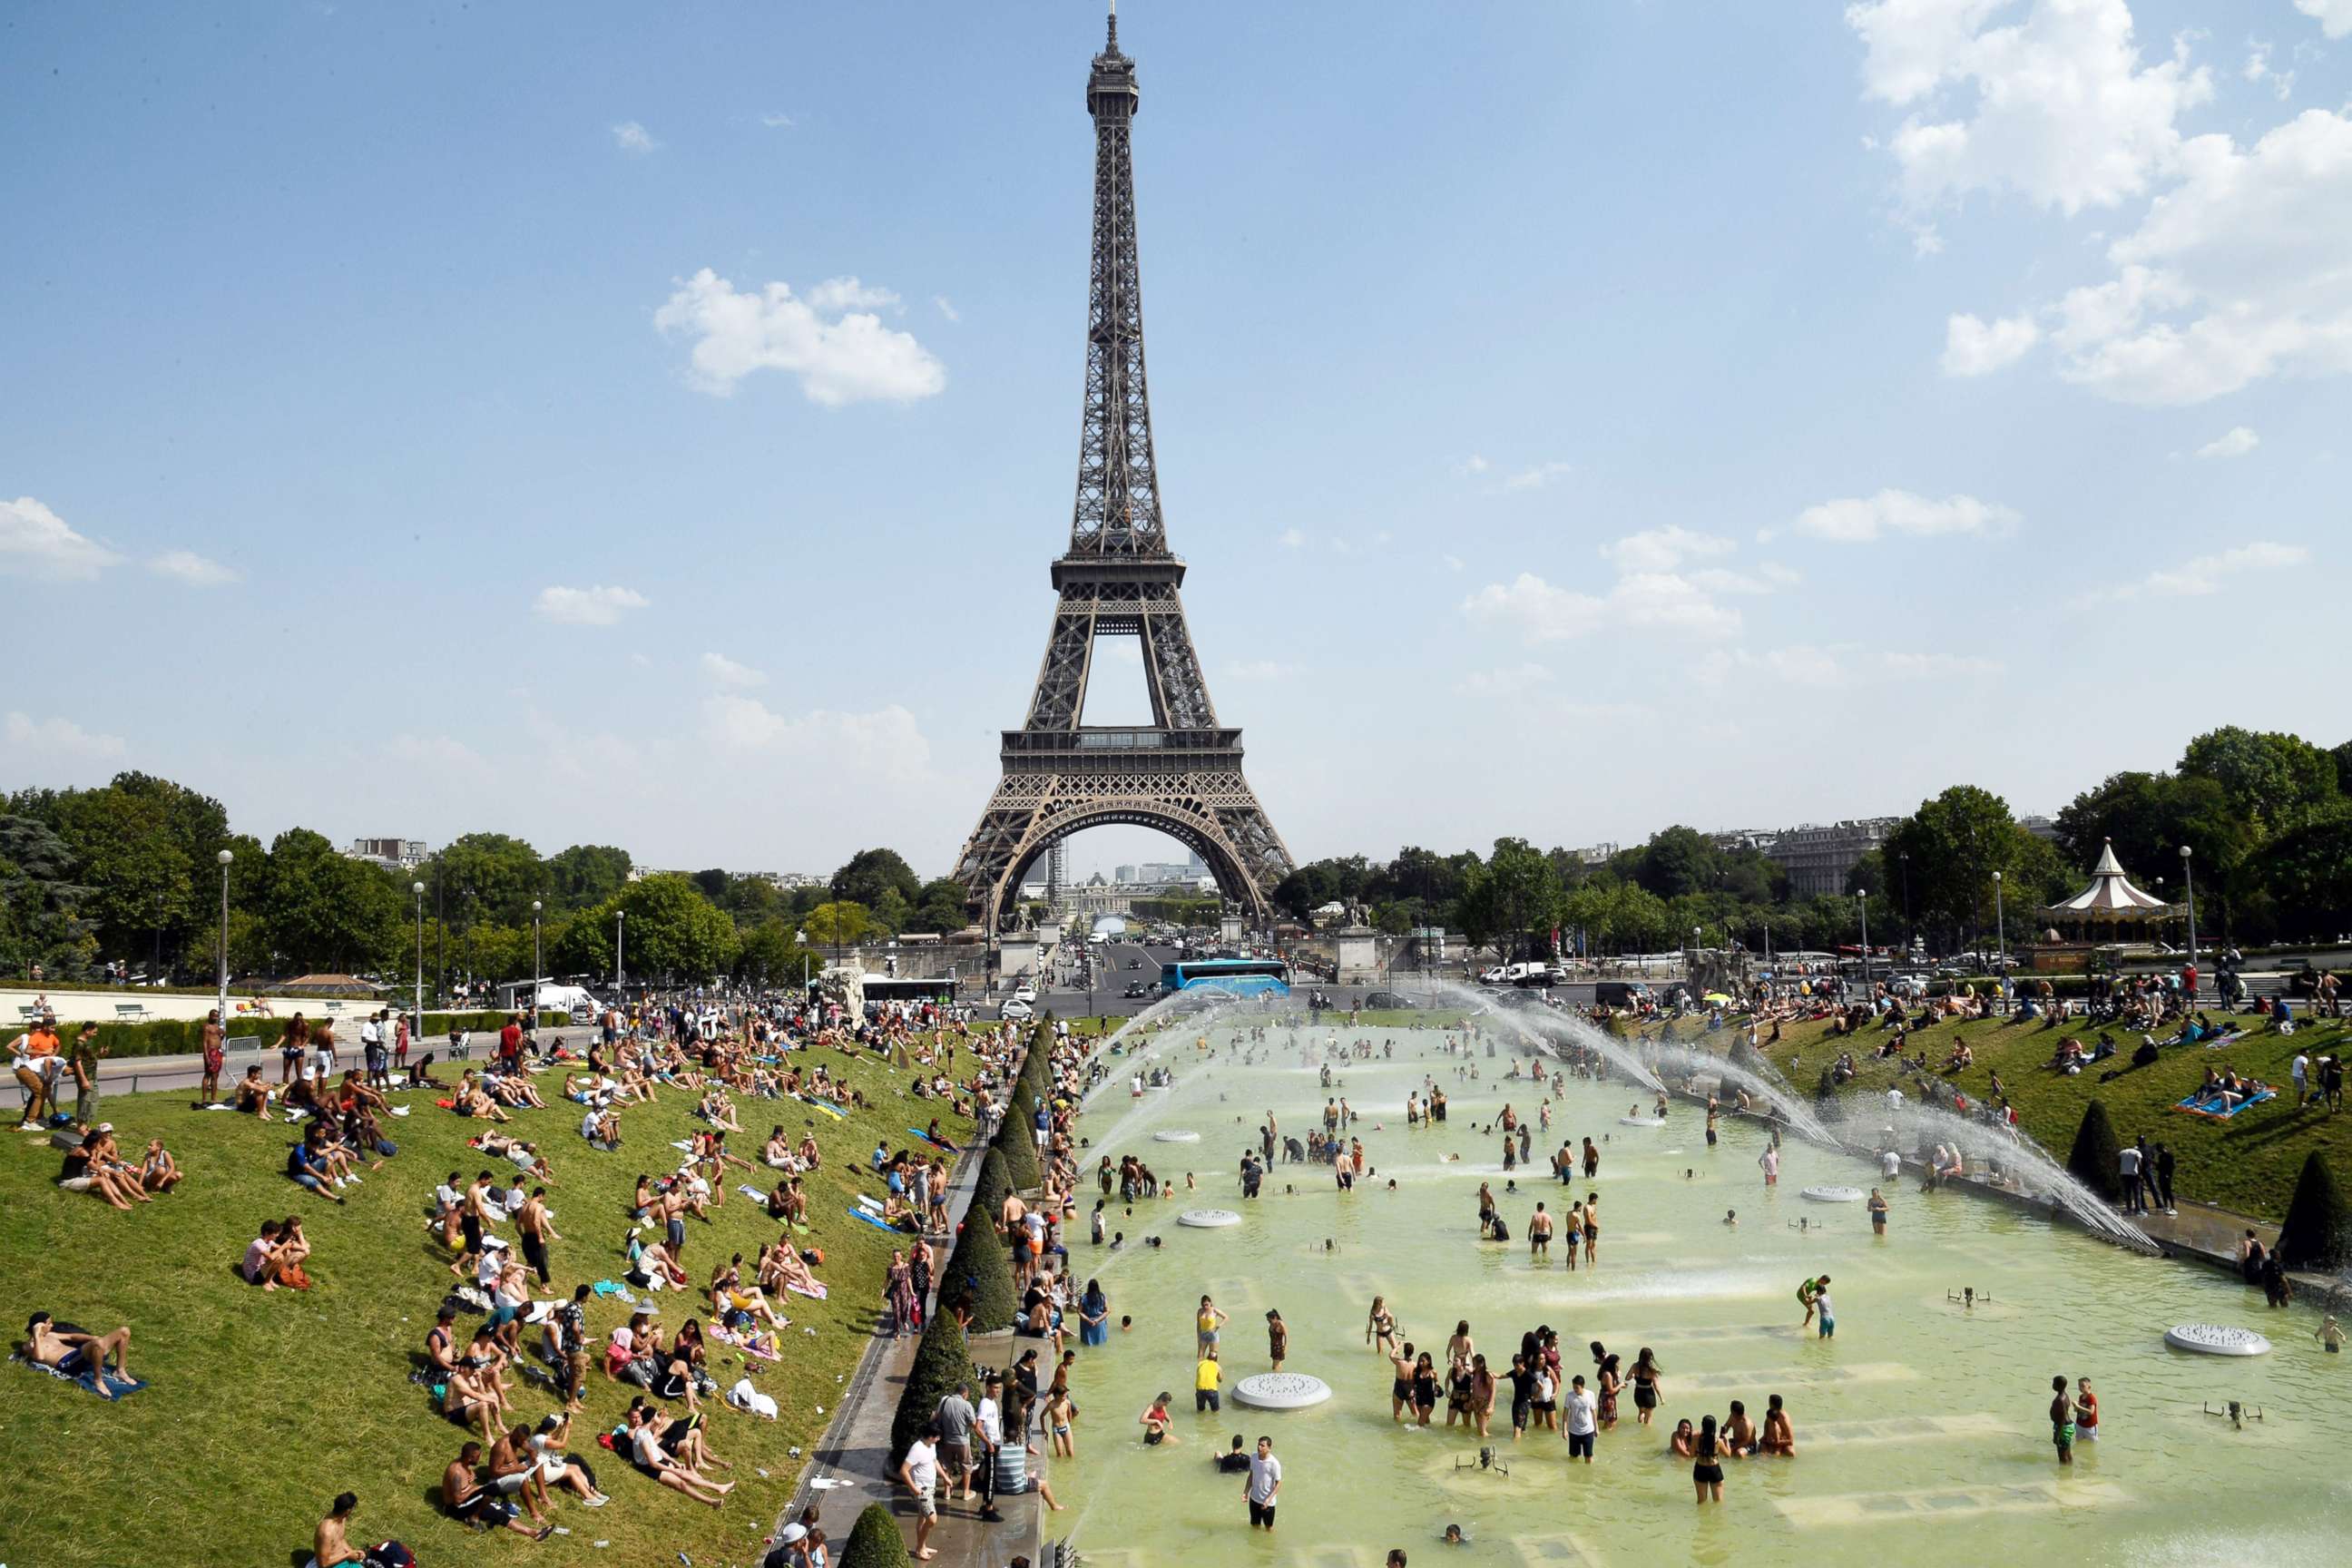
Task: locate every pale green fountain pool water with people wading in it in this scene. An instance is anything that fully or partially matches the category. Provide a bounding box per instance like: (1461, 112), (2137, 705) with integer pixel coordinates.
(1046, 1030), (2352, 1568)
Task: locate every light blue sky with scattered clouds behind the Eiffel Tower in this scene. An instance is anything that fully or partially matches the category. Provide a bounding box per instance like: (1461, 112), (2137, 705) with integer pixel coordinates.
(0, 0), (2352, 875)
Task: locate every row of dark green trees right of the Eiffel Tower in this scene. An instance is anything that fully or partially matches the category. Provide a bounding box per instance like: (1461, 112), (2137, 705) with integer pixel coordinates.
(1275, 727), (2352, 952)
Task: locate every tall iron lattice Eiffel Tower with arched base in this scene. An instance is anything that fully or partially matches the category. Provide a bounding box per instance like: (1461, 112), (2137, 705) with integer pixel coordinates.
(955, 0), (1291, 928)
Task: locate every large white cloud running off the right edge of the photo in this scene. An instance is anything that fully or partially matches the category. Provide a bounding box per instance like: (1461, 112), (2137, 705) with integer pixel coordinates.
(2053, 108), (2352, 405)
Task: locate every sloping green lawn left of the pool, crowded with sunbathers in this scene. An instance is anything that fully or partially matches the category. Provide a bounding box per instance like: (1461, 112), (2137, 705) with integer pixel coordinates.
(0, 1051), (971, 1568)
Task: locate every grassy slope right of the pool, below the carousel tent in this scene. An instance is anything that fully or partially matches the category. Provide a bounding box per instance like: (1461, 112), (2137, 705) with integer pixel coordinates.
(1618, 1015), (2352, 1220)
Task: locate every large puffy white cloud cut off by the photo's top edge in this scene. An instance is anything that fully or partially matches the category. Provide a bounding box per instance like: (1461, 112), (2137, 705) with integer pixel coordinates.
(1847, 0), (2213, 214)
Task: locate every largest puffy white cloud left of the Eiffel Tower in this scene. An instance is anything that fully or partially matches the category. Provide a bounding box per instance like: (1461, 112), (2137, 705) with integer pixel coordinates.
(654, 268), (948, 407)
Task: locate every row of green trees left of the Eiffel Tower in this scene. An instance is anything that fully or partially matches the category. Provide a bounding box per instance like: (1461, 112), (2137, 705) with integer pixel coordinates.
(0, 773), (966, 992)
